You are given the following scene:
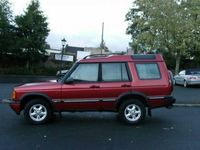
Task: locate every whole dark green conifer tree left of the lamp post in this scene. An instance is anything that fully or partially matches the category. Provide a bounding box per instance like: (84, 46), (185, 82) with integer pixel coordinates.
(15, 0), (49, 69)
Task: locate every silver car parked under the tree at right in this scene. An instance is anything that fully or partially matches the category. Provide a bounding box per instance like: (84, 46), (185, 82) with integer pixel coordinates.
(174, 68), (200, 87)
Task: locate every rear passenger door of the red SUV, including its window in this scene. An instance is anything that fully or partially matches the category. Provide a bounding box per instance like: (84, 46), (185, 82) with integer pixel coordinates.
(99, 62), (131, 110)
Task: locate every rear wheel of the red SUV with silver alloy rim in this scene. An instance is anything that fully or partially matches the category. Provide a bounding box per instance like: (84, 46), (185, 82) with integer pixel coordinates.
(119, 99), (146, 125)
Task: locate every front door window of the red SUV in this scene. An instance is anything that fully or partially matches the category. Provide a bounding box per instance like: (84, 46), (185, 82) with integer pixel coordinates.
(70, 63), (99, 82)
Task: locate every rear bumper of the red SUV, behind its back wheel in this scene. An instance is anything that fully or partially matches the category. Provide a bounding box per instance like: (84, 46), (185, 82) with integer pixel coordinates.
(148, 96), (176, 109)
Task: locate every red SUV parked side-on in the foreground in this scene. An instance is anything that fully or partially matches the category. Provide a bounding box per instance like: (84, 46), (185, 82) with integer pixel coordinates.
(4, 54), (175, 124)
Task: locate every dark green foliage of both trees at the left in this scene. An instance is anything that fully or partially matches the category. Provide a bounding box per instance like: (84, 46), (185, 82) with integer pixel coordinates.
(0, 0), (50, 72)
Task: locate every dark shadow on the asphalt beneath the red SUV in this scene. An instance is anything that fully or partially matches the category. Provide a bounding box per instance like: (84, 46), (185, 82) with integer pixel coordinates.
(14, 112), (168, 128)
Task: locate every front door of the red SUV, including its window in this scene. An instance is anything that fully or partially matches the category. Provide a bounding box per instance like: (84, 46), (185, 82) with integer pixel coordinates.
(61, 63), (101, 110)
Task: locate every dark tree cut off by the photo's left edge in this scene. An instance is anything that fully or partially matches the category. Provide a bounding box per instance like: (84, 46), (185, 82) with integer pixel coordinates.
(0, 0), (14, 58)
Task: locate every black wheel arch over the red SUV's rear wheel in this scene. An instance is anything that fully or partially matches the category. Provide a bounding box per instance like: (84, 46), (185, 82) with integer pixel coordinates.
(116, 92), (148, 110)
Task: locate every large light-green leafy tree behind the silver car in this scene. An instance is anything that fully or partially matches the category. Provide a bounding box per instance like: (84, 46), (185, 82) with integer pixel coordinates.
(126, 0), (200, 73)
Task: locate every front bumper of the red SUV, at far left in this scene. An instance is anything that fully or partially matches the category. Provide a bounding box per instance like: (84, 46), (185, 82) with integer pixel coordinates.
(0, 99), (21, 114)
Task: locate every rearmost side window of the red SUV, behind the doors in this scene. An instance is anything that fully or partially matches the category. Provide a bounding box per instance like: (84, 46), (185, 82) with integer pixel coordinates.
(135, 63), (161, 80)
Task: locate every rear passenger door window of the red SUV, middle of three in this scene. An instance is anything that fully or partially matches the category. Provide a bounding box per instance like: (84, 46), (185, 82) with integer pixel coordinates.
(102, 63), (129, 81)
